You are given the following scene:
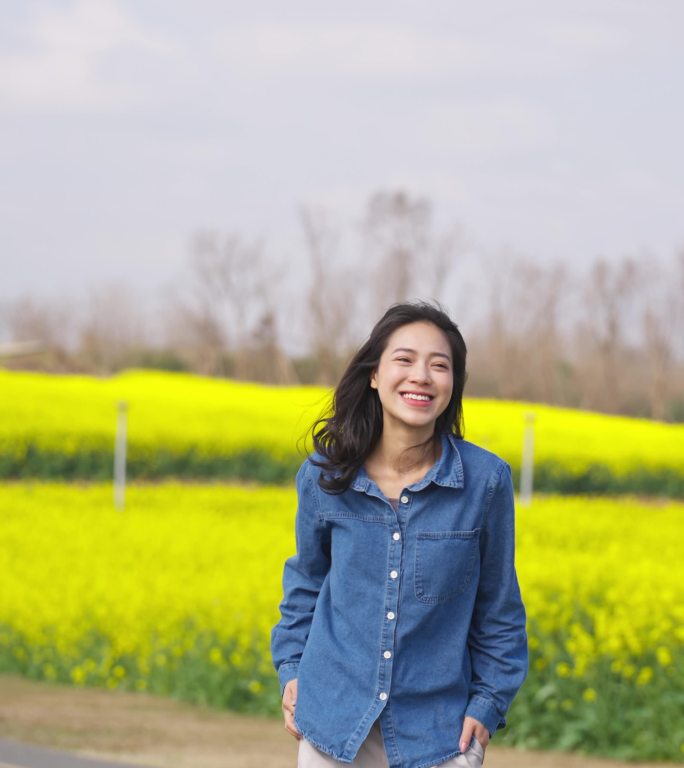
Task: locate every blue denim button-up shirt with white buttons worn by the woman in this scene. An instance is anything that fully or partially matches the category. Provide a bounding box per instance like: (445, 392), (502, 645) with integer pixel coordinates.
(271, 435), (527, 768)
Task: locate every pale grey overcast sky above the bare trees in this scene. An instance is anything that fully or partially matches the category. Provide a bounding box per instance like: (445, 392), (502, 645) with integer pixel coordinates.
(0, 0), (684, 306)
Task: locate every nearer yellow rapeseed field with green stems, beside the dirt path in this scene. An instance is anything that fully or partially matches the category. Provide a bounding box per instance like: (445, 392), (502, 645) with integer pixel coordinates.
(0, 483), (684, 760)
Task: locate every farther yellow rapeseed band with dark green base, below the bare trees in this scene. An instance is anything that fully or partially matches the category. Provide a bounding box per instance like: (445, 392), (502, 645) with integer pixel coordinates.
(0, 372), (684, 496)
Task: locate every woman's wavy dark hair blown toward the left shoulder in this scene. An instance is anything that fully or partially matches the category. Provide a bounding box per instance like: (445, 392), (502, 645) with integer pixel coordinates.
(311, 302), (466, 493)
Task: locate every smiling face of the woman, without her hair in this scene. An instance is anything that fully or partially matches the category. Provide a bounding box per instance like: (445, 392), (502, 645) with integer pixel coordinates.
(370, 321), (454, 433)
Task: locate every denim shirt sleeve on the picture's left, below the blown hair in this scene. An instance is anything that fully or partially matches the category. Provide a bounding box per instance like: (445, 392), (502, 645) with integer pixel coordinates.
(271, 460), (330, 696)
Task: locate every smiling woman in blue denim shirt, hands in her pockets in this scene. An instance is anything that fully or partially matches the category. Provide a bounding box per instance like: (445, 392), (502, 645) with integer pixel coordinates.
(272, 303), (527, 768)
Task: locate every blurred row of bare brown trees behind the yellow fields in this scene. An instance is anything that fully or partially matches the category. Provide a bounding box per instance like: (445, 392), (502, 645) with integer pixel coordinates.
(0, 192), (684, 422)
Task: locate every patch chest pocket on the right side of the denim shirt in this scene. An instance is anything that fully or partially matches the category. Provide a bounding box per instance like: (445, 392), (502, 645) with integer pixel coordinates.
(415, 528), (480, 605)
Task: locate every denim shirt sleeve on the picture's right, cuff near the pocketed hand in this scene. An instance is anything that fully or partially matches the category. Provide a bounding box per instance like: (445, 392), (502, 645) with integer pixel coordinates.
(465, 462), (527, 734)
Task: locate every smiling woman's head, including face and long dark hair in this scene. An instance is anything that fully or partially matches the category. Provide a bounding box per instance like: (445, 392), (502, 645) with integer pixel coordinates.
(312, 304), (466, 492)
